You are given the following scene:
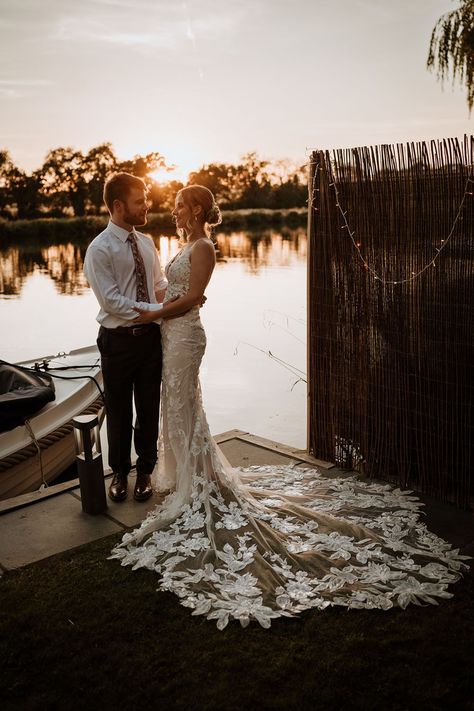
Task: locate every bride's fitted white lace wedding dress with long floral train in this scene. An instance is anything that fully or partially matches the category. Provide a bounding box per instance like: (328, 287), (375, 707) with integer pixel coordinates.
(111, 245), (467, 629)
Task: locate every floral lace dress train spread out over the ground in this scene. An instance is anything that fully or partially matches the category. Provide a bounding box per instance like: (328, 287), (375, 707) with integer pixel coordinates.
(114, 456), (467, 629)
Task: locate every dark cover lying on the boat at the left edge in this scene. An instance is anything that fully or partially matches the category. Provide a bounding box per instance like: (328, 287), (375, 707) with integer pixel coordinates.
(0, 361), (56, 432)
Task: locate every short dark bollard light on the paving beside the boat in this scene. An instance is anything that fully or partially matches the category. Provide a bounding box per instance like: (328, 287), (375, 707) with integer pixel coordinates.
(72, 415), (107, 515)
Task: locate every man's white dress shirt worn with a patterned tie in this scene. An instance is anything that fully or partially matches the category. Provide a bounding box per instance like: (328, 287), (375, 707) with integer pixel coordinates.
(84, 220), (168, 328)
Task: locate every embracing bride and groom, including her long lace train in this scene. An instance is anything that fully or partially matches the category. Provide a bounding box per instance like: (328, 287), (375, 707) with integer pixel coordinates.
(84, 173), (466, 629)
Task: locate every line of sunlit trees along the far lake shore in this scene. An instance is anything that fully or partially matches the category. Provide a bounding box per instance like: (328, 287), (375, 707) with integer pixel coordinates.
(0, 143), (307, 219)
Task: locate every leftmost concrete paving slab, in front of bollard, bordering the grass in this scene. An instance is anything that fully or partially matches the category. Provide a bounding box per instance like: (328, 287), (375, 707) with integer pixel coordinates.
(0, 493), (123, 570)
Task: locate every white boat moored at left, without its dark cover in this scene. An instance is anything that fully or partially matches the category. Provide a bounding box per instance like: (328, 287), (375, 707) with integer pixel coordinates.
(0, 346), (104, 500)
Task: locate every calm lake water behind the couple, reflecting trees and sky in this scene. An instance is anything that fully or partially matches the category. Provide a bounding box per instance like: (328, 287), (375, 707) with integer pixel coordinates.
(0, 229), (307, 448)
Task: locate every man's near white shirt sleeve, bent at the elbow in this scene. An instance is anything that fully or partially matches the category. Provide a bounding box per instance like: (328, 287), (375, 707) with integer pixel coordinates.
(84, 248), (163, 321)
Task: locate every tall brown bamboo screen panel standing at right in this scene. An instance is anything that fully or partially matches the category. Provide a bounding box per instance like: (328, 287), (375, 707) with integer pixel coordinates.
(308, 137), (474, 507)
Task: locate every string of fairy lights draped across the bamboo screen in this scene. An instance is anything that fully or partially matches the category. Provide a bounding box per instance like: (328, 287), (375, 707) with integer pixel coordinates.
(309, 161), (474, 285)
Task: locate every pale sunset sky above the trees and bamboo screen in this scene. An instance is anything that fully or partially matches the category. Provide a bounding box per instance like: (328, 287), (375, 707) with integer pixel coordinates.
(0, 0), (473, 177)
